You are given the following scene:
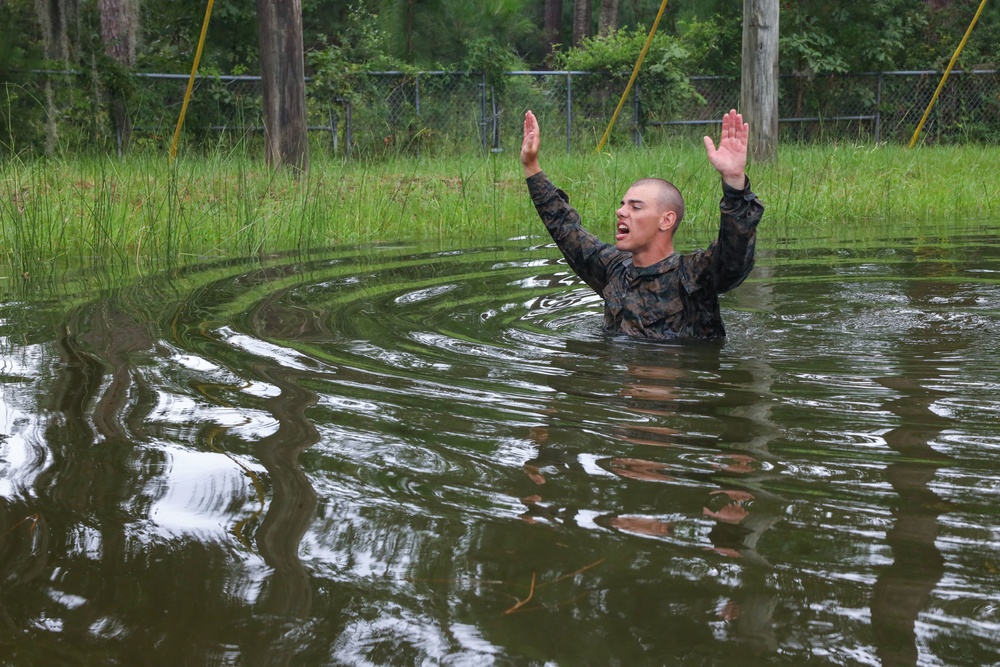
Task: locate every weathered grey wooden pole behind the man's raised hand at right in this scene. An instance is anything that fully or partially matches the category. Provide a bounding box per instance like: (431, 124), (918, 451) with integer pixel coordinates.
(740, 0), (778, 162)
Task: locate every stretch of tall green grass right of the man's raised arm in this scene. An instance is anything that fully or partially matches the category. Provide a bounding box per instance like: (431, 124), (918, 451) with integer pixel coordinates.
(758, 145), (1000, 248)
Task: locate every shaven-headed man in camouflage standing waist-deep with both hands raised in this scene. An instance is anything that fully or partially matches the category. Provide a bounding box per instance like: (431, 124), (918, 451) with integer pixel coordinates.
(521, 109), (764, 339)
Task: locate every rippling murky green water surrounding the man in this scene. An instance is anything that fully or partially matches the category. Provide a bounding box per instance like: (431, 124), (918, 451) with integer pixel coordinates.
(0, 227), (1000, 666)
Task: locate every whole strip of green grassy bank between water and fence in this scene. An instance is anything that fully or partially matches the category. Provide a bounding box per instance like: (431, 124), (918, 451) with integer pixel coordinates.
(0, 143), (1000, 271)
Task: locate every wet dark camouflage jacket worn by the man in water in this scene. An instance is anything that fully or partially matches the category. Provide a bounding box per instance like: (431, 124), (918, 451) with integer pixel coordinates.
(527, 172), (764, 339)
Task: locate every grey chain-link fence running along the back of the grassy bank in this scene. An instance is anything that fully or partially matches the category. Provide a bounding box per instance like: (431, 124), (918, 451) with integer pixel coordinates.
(9, 70), (1000, 157)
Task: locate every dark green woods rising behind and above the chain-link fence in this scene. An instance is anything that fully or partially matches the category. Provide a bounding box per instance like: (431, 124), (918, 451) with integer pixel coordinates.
(0, 0), (1000, 154)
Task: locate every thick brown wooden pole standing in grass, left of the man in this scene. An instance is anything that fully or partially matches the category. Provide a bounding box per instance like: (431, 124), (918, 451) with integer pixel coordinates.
(257, 0), (309, 172)
